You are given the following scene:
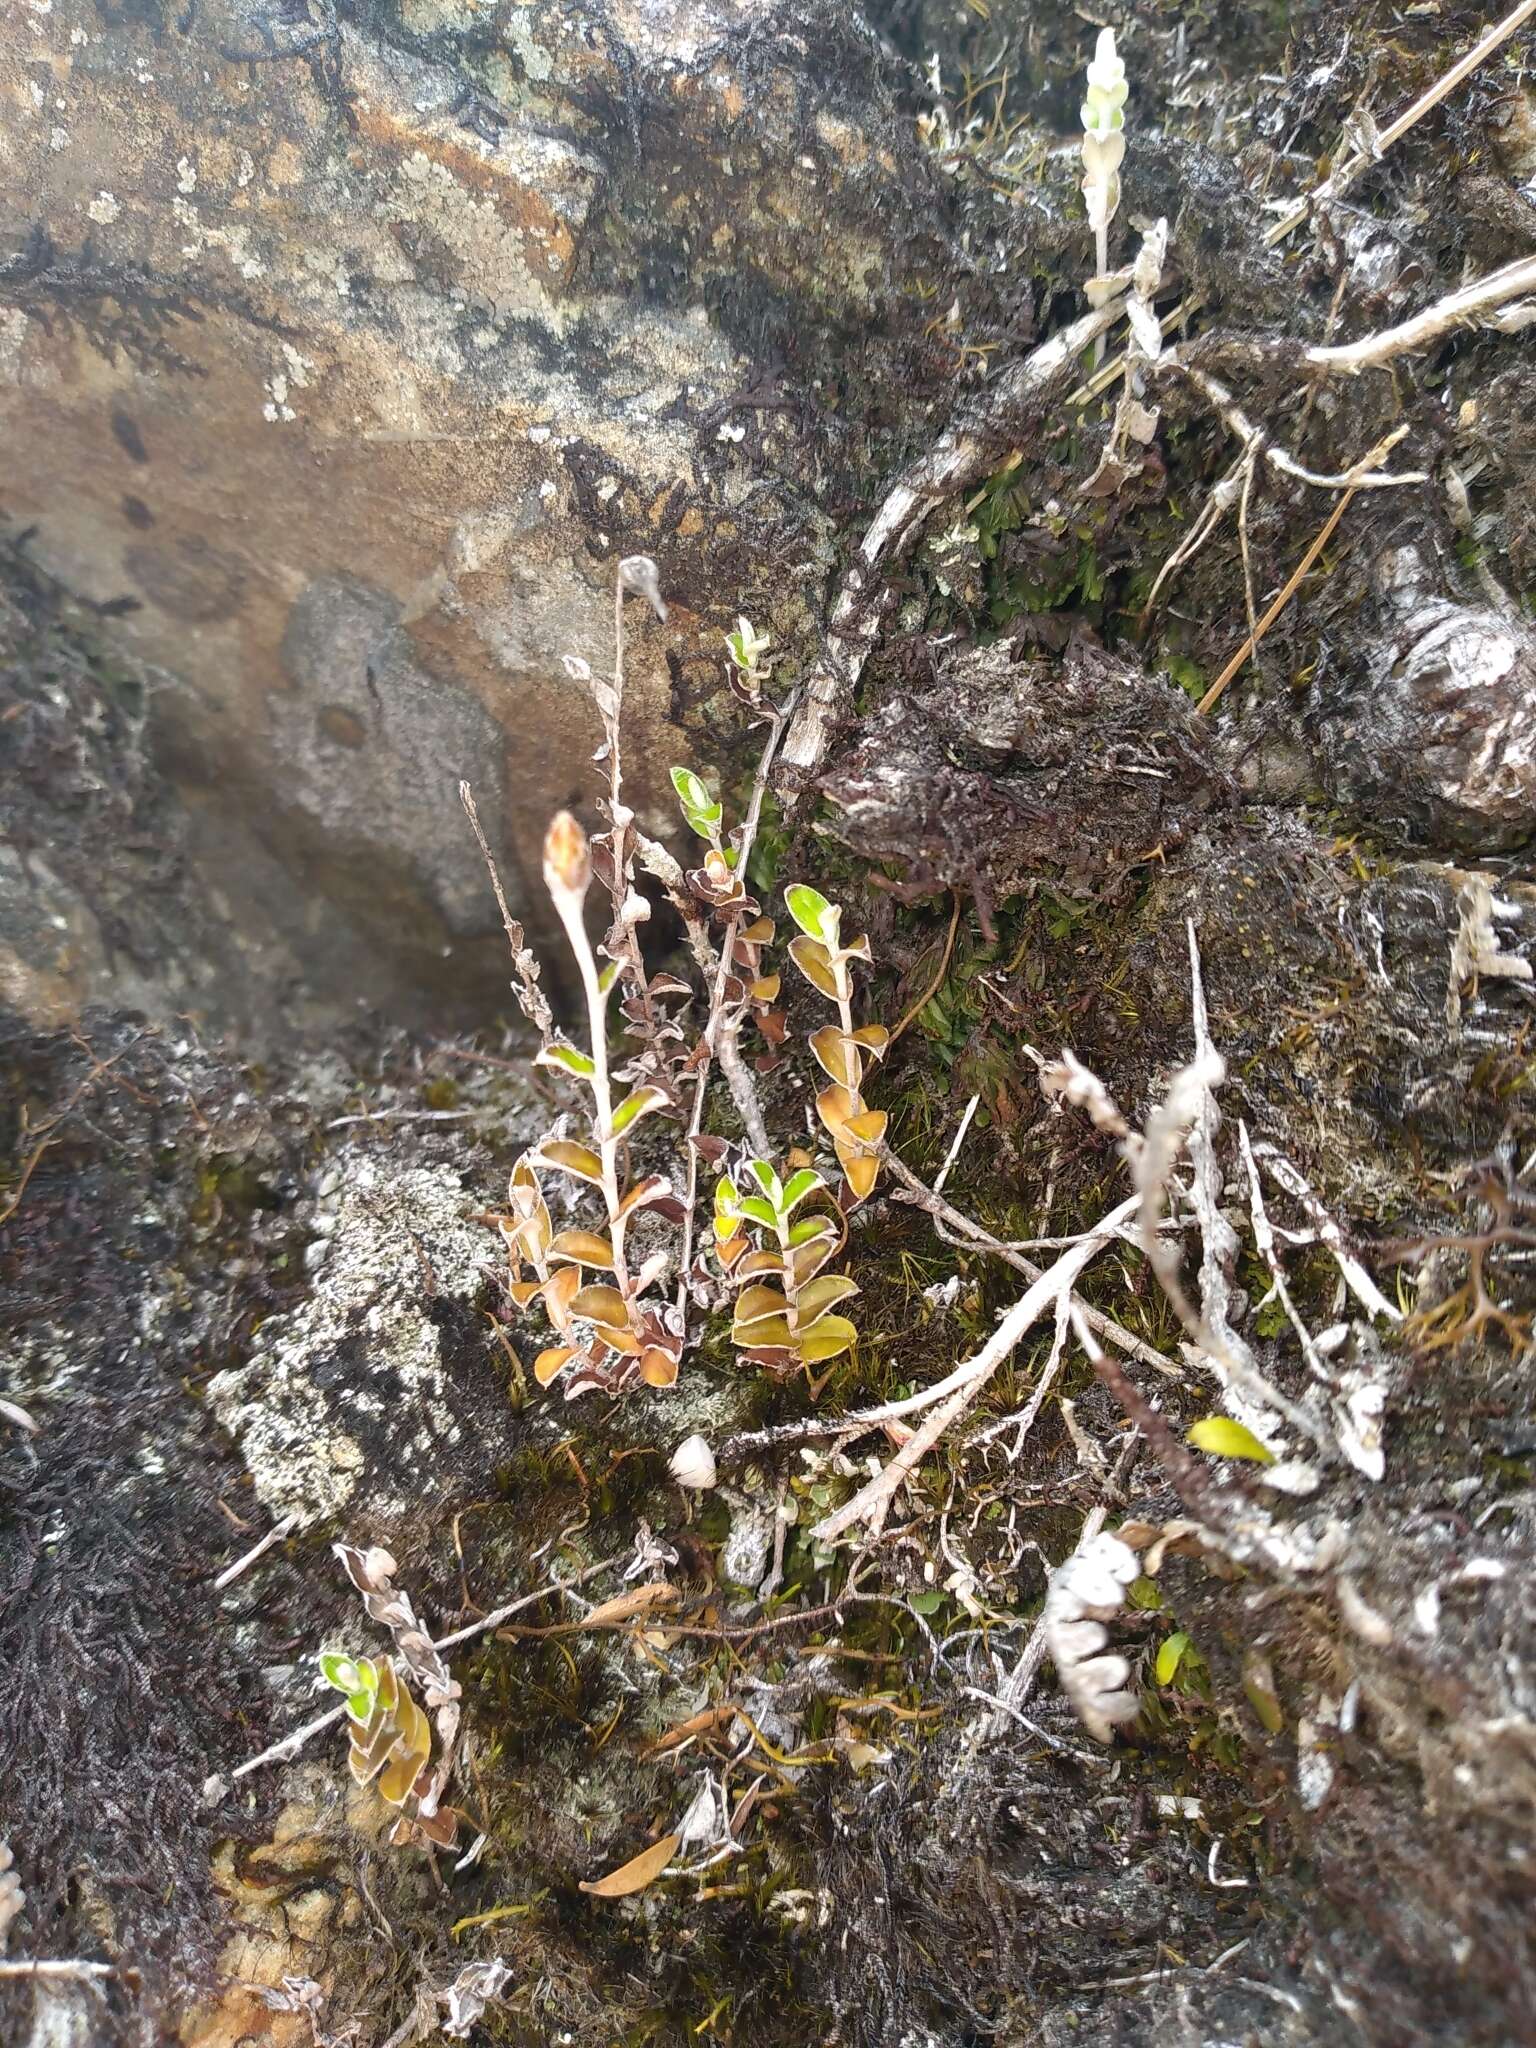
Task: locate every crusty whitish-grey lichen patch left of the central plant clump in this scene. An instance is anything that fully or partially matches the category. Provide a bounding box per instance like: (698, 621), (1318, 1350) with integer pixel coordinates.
(209, 1155), (492, 1528)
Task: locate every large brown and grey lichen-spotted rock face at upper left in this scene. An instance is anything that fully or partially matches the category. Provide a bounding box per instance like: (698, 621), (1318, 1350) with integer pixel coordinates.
(0, 0), (921, 1040)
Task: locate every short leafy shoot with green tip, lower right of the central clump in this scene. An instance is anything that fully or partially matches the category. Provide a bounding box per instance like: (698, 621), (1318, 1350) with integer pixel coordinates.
(715, 1159), (858, 1374)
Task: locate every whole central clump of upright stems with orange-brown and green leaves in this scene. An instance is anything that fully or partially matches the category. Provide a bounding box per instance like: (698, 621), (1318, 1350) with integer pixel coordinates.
(465, 555), (889, 1399)
